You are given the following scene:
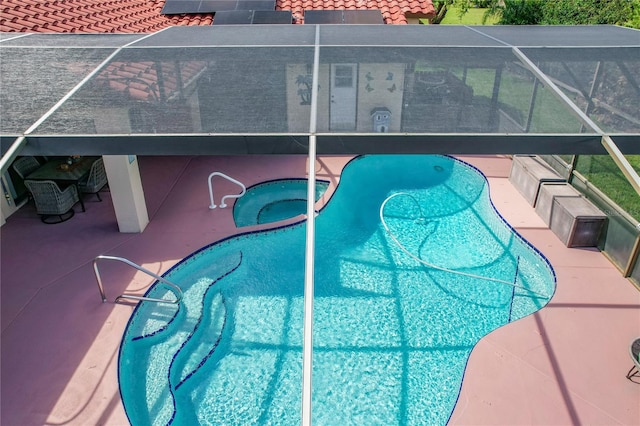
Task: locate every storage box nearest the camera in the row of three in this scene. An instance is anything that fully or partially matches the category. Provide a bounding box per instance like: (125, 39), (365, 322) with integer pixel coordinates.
(549, 197), (607, 247)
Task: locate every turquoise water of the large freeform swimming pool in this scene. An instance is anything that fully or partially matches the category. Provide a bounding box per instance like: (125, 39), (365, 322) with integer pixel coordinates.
(119, 155), (555, 425)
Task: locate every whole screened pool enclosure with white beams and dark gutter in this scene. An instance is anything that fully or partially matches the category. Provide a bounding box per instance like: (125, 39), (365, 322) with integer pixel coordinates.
(0, 24), (640, 424)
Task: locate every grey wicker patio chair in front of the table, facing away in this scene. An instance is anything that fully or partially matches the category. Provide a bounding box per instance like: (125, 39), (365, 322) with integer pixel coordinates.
(24, 179), (84, 224)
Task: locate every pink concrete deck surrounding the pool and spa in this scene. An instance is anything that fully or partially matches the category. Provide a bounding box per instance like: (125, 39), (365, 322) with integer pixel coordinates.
(0, 156), (640, 426)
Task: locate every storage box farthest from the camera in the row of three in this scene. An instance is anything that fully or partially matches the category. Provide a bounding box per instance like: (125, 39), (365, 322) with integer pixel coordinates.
(509, 155), (565, 207)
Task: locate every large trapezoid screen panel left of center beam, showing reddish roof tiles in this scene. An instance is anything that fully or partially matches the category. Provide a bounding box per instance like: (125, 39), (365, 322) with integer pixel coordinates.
(36, 47), (313, 135)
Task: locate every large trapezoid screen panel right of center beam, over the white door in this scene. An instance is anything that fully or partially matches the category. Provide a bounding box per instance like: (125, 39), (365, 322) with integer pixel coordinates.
(317, 47), (581, 133)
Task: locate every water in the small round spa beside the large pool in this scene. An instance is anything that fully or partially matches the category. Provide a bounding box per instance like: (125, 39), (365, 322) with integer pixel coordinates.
(233, 179), (329, 227)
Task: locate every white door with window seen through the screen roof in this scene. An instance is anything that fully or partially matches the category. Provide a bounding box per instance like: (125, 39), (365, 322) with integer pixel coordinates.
(329, 64), (358, 130)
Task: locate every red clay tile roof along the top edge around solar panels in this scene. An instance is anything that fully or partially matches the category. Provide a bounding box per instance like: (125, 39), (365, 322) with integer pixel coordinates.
(0, 0), (434, 33)
